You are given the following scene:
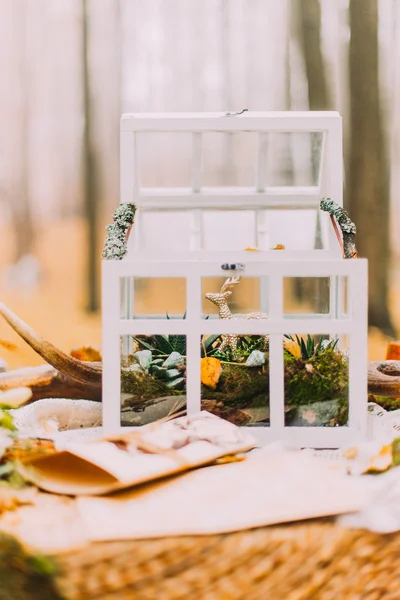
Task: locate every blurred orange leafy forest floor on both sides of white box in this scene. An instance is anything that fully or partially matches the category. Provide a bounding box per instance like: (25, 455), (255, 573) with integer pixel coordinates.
(0, 219), (400, 368)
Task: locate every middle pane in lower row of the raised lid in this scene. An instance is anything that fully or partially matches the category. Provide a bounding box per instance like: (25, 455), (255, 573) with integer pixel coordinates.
(203, 210), (256, 250)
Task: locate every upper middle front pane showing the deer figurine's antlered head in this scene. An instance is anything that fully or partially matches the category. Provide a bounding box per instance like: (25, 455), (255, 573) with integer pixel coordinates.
(201, 276), (268, 319)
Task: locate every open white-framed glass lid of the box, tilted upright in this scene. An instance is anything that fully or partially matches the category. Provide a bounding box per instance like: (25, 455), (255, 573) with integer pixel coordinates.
(121, 112), (342, 254)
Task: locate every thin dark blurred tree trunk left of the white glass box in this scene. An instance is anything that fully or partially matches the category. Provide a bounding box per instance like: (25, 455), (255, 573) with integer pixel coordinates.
(82, 0), (99, 312)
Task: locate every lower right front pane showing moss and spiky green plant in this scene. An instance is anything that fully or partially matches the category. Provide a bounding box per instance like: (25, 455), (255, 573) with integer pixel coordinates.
(284, 334), (349, 427)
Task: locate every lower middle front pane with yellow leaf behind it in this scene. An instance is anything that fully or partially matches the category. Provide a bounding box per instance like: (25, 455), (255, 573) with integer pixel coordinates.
(201, 334), (269, 427)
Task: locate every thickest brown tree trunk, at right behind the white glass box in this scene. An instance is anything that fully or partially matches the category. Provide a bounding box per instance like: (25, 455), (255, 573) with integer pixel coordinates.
(347, 0), (395, 335)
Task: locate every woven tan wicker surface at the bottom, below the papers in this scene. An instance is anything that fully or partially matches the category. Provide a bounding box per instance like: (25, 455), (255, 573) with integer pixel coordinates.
(47, 521), (400, 600)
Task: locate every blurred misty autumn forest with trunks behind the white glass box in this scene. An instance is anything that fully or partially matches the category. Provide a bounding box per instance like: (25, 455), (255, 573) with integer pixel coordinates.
(0, 0), (400, 366)
